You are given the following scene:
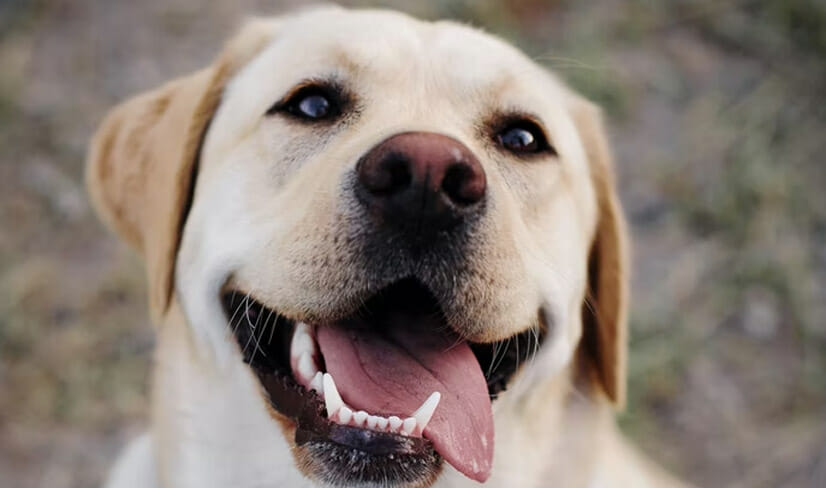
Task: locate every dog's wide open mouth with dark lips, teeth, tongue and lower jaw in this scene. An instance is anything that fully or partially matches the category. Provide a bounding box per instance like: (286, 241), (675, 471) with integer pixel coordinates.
(223, 279), (544, 485)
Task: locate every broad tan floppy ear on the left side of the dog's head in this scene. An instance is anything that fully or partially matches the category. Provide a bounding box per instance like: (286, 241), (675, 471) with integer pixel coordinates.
(86, 20), (276, 323)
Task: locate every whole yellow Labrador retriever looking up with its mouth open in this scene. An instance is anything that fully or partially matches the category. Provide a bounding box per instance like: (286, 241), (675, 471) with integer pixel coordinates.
(88, 8), (680, 488)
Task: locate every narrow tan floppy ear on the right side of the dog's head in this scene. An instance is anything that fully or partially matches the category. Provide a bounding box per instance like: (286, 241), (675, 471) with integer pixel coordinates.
(572, 97), (629, 408)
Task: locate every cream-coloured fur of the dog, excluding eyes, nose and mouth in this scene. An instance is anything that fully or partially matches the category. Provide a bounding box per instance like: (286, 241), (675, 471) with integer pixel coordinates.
(88, 8), (682, 488)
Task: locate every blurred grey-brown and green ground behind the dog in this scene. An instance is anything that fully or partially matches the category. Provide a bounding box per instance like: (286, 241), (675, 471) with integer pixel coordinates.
(0, 0), (826, 488)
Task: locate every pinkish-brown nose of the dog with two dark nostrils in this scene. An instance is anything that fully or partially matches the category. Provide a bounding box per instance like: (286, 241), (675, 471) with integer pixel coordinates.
(356, 132), (487, 230)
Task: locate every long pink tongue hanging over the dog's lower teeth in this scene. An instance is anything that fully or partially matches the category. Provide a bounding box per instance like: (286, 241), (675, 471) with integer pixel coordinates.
(317, 319), (493, 481)
